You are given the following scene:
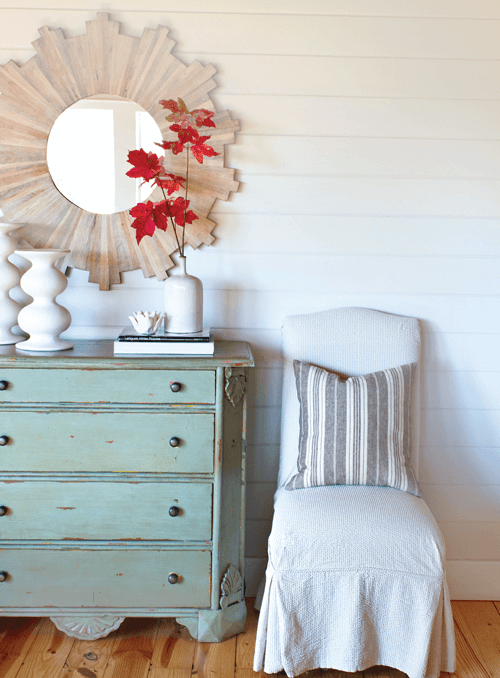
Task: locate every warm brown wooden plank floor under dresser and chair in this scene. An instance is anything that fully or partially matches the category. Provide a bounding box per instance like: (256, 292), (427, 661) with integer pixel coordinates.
(0, 599), (500, 678)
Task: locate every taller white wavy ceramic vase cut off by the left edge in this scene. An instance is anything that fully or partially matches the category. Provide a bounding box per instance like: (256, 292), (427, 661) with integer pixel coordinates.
(0, 223), (23, 345)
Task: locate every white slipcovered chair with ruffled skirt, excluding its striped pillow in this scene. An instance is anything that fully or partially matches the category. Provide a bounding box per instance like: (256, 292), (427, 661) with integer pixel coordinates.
(254, 308), (455, 678)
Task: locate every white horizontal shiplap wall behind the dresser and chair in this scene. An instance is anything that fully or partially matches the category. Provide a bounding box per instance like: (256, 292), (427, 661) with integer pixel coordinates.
(0, 0), (500, 599)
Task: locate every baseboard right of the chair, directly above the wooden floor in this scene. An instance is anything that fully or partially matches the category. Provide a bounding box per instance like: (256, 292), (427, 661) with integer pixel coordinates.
(446, 560), (500, 600)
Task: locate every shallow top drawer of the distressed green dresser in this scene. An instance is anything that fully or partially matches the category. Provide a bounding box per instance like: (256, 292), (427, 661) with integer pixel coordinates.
(0, 368), (215, 405)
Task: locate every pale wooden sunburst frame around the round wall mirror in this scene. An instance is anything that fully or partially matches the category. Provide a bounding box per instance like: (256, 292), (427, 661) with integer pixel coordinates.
(0, 13), (239, 290)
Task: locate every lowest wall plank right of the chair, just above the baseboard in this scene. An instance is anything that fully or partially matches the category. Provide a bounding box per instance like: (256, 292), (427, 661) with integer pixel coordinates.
(438, 521), (500, 561)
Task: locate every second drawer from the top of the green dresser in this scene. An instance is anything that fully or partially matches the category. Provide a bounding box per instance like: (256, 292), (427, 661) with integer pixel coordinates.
(0, 411), (214, 473)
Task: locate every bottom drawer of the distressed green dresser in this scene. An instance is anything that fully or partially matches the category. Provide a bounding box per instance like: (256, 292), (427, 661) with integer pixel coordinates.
(0, 548), (211, 609)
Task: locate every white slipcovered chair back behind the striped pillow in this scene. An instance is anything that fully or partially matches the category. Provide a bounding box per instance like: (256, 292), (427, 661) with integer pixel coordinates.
(278, 308), (420, 493)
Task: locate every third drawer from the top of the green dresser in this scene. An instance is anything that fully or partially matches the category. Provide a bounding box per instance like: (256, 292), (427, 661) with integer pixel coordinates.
(0, 480), (212, 541)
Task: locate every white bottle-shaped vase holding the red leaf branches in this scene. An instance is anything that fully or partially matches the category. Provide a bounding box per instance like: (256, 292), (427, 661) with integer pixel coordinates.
(165, 257), (203, 334)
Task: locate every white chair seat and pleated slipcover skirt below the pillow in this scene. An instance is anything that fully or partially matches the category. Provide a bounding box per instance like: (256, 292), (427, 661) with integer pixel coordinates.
(254, 485), (455, 678)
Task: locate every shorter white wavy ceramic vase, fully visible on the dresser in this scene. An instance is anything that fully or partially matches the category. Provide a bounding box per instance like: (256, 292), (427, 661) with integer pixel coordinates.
(16, 250), (73, 351)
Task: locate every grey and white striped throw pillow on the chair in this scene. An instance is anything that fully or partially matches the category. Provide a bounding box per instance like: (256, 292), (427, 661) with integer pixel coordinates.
(286, 360), (422, 497)
